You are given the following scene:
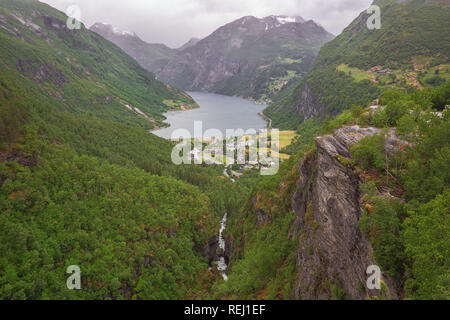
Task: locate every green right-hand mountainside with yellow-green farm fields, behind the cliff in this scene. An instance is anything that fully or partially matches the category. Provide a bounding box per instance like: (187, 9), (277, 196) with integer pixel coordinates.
(264, 0), (450, 128)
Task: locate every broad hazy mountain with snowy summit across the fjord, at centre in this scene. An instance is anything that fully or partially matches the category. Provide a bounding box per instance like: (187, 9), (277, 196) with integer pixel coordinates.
(158, 16), (333, 100)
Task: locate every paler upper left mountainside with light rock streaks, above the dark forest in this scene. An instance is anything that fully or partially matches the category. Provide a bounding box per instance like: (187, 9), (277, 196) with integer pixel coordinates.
(0, 0), (195, 129)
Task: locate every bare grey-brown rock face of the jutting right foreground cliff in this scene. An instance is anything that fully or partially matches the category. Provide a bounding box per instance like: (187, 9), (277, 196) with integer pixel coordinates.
(290, 126), (399, 299)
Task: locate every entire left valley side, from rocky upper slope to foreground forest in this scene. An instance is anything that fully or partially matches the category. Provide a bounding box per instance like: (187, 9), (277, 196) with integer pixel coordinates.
(0, 0), (240, 300)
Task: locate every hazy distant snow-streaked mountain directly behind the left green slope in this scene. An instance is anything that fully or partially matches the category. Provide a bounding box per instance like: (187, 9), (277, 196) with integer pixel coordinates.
(90, 23), (177, 74)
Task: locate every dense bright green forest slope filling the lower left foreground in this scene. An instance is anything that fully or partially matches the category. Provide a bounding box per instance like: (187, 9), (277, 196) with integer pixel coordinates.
(0, 145), (216, 299)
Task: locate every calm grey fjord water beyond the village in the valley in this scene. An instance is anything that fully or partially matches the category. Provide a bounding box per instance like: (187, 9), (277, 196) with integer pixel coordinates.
(152, 92), (266, 139)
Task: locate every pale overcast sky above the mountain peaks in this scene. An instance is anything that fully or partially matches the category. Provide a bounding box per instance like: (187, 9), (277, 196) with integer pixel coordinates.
(41, 0), (373, 48)
